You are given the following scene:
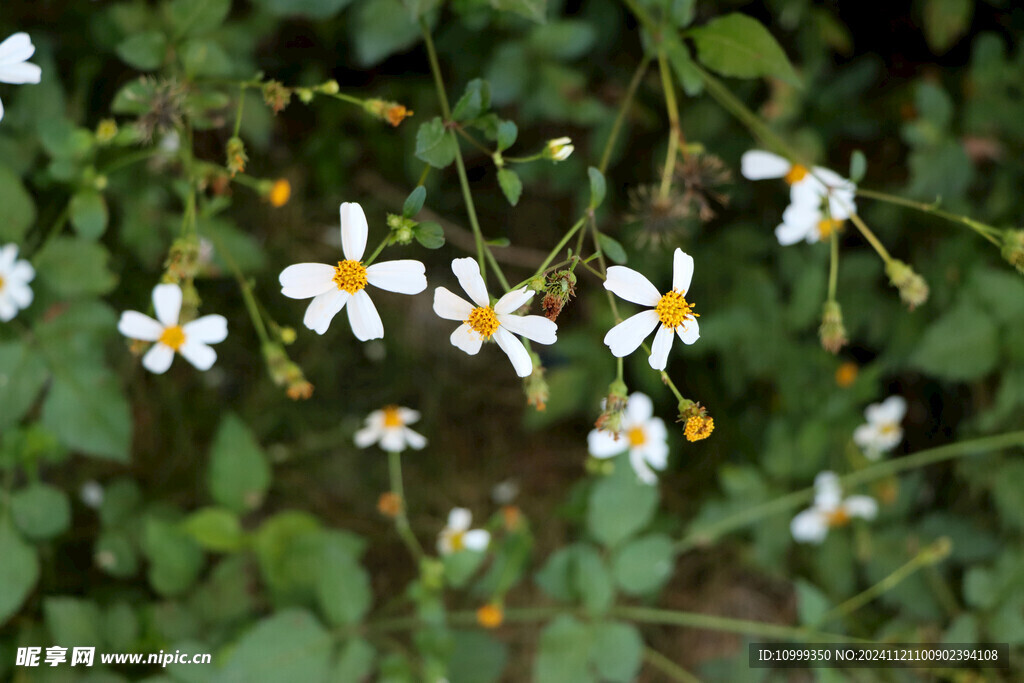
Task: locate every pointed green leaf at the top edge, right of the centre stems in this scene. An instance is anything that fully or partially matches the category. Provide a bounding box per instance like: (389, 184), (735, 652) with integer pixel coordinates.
(687, 12), (800, 87)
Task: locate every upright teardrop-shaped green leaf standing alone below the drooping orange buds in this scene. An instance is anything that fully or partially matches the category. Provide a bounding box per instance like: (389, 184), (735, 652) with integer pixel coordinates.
(207, 413), (270, 514)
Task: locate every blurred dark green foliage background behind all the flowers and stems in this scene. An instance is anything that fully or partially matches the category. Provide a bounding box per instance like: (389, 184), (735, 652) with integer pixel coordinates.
(0, 0), (1024, 683)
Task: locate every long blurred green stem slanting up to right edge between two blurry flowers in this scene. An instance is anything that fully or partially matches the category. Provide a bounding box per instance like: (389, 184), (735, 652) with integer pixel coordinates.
(676, 431), (1024, 553)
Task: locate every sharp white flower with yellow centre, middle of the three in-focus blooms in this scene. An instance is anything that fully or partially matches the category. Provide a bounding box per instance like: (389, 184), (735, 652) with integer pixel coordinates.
(434, 258), (558, 377)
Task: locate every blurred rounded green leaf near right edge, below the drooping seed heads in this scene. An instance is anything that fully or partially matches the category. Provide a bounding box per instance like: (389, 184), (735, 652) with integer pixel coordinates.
(910, 304), (999, 381)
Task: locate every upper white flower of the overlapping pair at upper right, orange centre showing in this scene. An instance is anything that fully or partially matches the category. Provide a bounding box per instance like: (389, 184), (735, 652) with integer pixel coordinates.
(740, 150), (857, 220)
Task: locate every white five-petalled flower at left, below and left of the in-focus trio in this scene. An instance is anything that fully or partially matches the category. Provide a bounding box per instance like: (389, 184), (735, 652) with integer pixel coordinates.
(118, 285), (227, 375)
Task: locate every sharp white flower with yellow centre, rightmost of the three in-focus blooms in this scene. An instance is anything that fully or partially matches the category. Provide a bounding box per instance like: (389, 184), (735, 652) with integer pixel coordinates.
(604, 249), (700, 370)
